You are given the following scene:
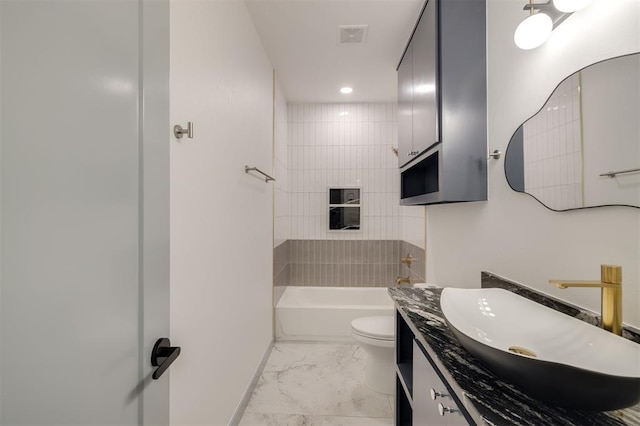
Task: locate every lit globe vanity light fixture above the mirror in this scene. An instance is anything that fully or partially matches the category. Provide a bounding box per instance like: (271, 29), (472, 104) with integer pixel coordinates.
(513, 0), (580, 50)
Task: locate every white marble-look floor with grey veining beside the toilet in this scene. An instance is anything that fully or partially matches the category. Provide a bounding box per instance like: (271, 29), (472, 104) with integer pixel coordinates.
(241, 342), (393, 425)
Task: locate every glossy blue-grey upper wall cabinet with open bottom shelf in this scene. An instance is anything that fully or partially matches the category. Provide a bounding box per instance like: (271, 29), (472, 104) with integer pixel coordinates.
(398, 0), (487, 205)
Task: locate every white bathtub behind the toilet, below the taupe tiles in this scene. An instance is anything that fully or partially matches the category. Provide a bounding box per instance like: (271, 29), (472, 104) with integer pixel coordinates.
(276, 287), (393, 342)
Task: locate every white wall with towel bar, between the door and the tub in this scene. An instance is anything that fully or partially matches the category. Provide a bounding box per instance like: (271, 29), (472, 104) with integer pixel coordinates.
(170, 0), (273, 425)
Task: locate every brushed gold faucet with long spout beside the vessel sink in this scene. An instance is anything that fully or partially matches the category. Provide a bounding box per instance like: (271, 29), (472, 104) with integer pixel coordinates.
(549, 265), (622, 336)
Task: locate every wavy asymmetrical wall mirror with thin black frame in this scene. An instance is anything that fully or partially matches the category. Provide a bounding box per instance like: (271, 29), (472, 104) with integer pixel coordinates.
(504, 53), (640, 211)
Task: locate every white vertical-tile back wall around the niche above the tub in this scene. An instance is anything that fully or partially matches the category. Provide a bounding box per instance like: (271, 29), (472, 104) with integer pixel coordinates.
(287, 103), (401, 240)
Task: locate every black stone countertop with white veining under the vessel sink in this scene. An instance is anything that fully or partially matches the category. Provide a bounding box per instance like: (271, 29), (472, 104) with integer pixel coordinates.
(389, 288), (640, 426)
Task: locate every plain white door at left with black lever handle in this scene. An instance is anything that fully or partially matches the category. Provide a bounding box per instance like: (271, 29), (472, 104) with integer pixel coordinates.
(0, 0), (170, 425)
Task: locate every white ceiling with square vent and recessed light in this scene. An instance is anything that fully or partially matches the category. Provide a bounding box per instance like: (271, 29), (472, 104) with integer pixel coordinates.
(245, 0), (423, 103)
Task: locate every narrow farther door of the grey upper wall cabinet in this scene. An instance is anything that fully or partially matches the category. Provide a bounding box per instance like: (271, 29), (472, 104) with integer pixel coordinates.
(398, 44), (413, 167)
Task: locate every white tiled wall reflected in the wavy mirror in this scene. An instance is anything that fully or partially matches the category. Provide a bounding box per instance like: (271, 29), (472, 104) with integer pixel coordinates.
(523, 73), (584, 210)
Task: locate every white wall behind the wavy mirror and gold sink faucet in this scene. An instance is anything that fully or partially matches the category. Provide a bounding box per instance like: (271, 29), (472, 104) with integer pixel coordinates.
(427, 0), (640, 326)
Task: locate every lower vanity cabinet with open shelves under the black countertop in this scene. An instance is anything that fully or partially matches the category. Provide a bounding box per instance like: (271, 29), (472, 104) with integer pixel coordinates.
(395, 311), (469, 426)
